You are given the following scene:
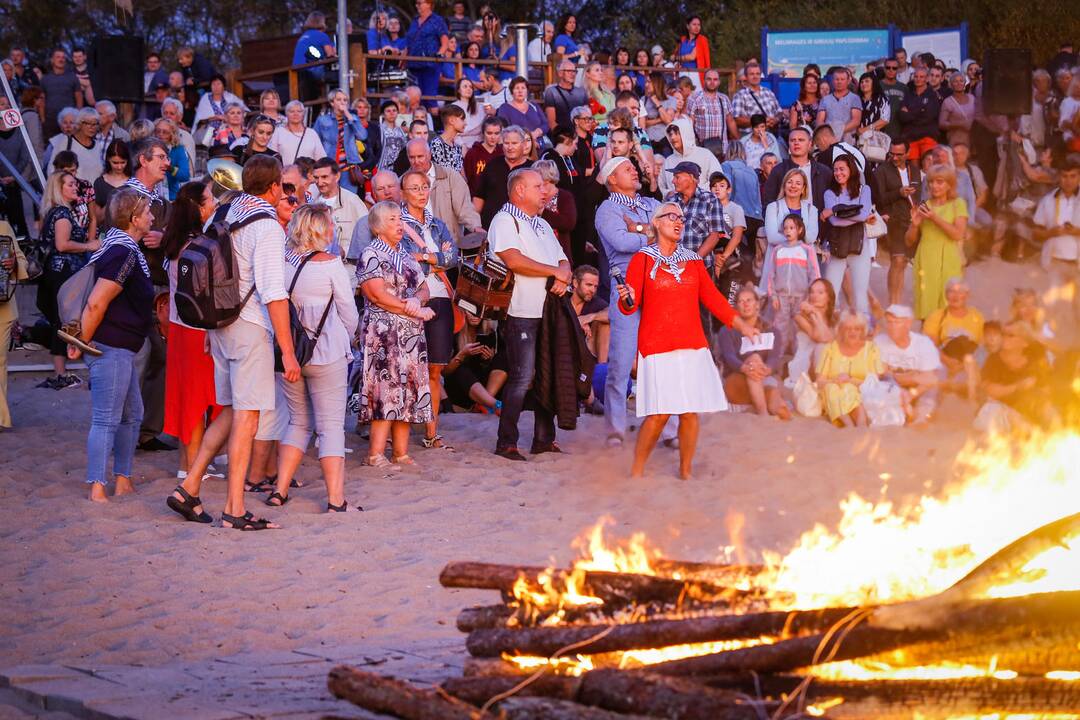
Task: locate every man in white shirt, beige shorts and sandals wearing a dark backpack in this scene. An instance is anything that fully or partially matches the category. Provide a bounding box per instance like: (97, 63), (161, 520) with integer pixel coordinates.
(167, 155), (300, 530)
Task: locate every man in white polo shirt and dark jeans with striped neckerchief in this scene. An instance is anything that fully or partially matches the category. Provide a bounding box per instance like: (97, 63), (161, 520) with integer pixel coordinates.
(487, 167), (571, 461)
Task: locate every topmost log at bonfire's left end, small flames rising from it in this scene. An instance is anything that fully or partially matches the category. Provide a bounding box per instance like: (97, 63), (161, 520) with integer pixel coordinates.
(438, 562), (756, 607)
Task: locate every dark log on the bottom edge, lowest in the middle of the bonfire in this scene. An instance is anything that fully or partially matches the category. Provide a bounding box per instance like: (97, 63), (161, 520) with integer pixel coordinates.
(442, 669), (777, 720)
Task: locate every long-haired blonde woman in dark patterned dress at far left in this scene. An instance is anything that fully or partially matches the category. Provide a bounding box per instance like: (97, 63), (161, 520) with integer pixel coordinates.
(38, 171), (100, 390)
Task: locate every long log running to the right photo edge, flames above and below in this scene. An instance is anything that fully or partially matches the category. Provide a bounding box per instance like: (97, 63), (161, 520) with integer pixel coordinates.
(649, 590), (1080, 675)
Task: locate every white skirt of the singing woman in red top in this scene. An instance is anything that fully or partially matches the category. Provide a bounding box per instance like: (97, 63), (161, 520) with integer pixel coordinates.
(637, 348), (728, 418)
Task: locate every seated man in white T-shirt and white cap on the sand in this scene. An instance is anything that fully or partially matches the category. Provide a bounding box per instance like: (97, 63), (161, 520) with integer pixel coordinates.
(874, 304), (944, 424)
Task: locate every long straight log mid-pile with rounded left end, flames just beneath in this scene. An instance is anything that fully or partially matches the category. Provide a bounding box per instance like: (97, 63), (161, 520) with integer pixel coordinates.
(465, 608), (852, 657)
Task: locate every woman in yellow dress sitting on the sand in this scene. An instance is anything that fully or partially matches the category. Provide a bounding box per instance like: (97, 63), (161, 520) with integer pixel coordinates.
(816, 310), (885, 427)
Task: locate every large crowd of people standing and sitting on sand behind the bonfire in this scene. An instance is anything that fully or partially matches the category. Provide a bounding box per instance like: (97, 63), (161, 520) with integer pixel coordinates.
(0, 18), (1080, 530)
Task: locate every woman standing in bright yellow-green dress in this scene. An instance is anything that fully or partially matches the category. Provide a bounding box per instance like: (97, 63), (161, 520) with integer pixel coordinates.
(905, 165), (968, 320)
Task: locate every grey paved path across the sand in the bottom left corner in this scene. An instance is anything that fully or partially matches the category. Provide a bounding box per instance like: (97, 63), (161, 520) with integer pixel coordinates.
(0, 640), (465, 720)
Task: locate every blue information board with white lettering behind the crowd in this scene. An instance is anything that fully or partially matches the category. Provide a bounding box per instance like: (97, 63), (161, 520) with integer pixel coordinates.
(761, 27), (893, 78)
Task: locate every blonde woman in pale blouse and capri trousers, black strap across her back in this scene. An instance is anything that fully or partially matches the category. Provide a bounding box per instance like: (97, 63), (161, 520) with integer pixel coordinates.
(266, 205), (360, 513)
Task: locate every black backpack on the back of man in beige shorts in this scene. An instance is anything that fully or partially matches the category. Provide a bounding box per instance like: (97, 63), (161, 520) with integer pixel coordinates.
(175, 199), (278, 330)
